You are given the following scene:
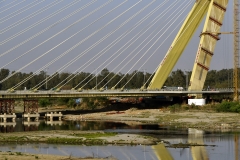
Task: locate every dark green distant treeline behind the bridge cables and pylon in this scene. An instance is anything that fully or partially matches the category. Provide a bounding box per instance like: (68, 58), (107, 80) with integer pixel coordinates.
(0, 69), (233, 90)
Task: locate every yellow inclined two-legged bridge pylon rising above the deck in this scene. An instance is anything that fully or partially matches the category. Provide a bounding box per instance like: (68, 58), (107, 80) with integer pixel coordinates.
(148, 0), (228, 94)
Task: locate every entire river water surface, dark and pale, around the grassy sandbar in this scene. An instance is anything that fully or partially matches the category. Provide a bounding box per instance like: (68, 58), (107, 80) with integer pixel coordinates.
(0, 119), (240, 160)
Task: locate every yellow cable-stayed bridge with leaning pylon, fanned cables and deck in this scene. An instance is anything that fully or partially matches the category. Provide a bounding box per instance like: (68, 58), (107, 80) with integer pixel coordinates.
(0, 0), (236, 98)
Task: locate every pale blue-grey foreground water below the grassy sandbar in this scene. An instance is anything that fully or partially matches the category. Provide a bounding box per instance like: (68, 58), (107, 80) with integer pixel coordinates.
(0, 134), (240, 160)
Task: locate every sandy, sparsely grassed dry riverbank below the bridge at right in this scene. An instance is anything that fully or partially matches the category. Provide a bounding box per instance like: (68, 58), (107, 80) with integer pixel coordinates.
(64, 108), (240, 130)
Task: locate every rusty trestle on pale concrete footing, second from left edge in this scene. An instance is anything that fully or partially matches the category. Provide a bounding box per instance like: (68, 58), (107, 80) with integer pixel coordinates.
(22, 100), (40, 122)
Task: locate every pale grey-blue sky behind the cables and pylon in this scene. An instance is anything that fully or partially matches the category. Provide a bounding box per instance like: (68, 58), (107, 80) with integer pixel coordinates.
(0, 0), (233, 74)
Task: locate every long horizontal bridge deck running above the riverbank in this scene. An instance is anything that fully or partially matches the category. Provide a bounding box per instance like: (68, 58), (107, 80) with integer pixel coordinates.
(0, 89), (233, 99)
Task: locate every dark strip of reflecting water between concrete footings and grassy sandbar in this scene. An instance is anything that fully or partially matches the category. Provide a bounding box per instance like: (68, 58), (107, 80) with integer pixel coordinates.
(0, 118), (167, 133)
